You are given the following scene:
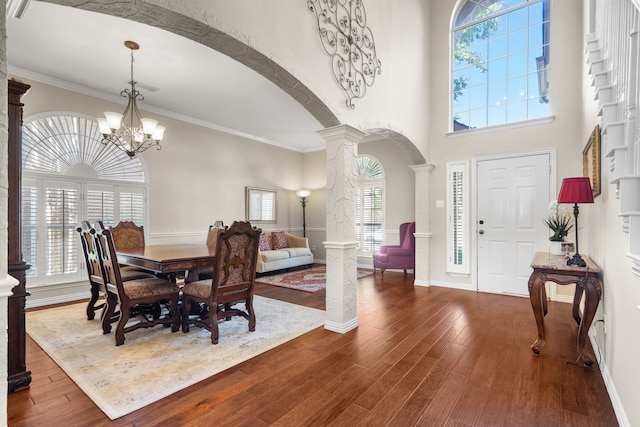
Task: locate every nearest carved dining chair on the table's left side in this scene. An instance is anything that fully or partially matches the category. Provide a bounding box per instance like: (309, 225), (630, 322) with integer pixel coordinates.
(91, 229), (180, 346)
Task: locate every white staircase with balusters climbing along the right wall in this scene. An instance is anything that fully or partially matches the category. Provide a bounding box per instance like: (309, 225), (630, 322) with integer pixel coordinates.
(585, 0), (640, 276)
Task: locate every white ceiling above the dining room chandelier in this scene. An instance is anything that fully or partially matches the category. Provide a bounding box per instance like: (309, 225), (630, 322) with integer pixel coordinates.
(7, 1), (326, 152)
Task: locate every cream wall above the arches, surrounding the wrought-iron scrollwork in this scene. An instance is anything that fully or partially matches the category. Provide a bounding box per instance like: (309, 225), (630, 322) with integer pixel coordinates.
(148, 0), (431, 154)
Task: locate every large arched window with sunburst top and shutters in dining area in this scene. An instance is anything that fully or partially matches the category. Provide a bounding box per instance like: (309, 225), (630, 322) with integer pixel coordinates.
(22, 113), (147, 286)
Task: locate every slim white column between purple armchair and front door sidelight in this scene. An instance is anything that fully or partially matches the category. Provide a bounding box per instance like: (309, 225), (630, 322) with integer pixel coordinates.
(409, 163), (436, 286)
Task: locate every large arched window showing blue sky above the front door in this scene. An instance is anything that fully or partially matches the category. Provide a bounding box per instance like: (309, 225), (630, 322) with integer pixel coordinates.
(451, 0), (550, 131)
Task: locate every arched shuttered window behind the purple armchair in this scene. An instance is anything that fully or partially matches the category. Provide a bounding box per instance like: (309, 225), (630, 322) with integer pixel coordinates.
(356, 156), (384, 256)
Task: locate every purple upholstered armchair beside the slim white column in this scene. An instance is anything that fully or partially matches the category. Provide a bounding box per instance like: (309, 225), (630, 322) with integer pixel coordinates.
(373, 222), (416, 277)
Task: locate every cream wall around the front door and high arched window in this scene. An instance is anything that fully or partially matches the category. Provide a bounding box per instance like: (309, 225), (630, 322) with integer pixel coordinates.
(428, 0), (587, 286)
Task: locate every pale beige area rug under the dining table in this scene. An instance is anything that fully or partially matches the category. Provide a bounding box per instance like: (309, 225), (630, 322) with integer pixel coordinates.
(27, 296), (325, 420)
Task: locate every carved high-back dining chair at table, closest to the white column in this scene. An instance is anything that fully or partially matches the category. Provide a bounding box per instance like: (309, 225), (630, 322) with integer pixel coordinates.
(182, 221), (262, 344)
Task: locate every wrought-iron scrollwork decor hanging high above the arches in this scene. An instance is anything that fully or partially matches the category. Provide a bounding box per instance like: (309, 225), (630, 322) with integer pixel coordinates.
(307, 0), (382, 108)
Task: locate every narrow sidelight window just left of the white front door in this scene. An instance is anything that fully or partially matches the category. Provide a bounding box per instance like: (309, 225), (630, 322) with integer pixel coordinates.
(447, 162), (470, 274)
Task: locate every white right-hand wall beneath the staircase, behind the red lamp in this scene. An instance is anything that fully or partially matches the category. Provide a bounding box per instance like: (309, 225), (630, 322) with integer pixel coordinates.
(580, 0), (640, 426)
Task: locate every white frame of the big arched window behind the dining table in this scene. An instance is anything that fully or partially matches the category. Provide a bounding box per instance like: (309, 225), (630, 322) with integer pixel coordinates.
(21, 112), (149, 288)
